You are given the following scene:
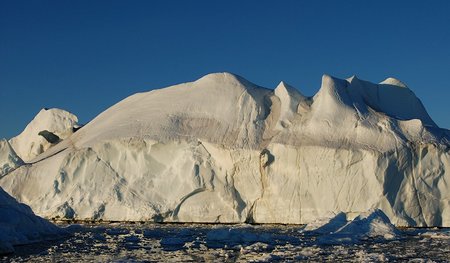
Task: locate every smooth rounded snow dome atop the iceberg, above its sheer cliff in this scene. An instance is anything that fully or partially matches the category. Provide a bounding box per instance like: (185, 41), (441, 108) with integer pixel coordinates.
(65, 73), (271, 149)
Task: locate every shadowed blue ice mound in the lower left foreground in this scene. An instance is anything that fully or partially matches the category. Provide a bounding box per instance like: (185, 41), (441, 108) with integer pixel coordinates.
(0, 188), (66, 254)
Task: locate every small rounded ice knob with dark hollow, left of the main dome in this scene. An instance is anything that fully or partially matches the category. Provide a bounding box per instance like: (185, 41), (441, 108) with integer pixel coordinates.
(9, 109), (78, 162)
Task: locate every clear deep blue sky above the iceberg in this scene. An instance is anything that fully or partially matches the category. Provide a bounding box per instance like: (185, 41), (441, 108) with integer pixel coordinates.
(0, 0), (450, 138)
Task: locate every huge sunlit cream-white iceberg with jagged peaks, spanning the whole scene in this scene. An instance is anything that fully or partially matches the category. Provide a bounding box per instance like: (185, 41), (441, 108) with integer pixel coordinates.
(0, 73), (450, 227)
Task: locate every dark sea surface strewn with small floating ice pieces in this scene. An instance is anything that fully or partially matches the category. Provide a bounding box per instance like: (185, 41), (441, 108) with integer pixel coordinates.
(0, 223), (450, 262)
